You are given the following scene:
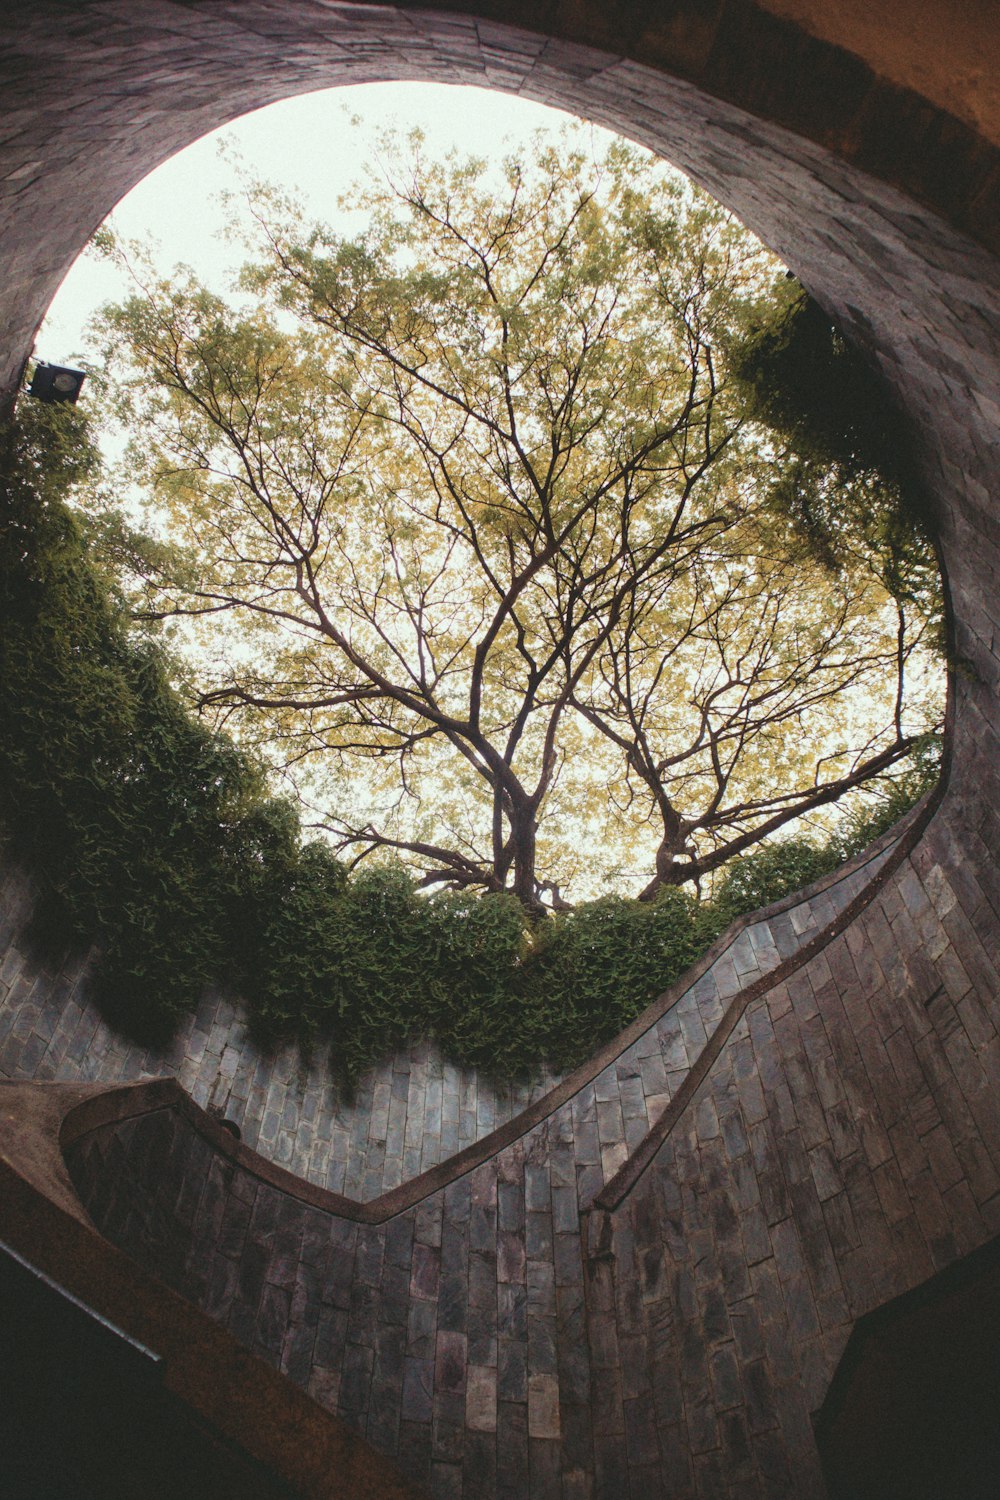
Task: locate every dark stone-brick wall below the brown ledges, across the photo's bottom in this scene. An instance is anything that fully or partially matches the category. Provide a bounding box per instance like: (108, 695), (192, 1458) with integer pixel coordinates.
(67, 810), (1000, 1500)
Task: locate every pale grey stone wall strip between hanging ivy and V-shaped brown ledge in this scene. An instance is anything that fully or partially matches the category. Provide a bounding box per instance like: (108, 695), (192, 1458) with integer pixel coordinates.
(0, 872), (555, 1199)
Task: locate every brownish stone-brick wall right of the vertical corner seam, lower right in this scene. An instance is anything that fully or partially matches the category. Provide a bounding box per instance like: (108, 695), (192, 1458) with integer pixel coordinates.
(589, 810), (1000, 1496)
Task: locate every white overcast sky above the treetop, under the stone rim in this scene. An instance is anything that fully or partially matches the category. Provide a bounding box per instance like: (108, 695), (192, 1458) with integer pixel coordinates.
(36, 83), (617, 365)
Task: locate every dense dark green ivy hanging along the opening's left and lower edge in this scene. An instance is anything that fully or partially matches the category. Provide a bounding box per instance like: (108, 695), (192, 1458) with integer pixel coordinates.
(0, 408), (937, 1079)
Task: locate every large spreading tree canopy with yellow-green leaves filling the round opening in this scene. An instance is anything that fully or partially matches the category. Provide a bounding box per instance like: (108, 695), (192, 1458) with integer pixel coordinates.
(88, 135), (947, 909)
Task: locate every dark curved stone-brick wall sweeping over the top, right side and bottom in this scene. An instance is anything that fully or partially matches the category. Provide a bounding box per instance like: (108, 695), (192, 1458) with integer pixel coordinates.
(0, 0), (1000, 1500)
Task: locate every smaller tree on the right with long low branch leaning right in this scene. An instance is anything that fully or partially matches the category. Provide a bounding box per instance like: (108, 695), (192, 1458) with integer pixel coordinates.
(576, 540), (947, 899)
